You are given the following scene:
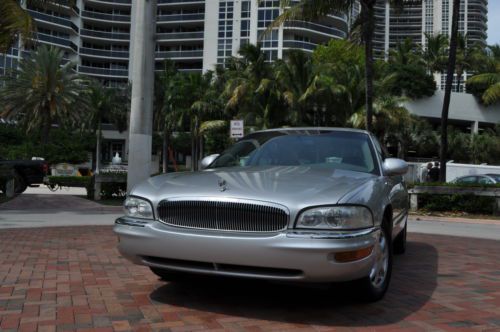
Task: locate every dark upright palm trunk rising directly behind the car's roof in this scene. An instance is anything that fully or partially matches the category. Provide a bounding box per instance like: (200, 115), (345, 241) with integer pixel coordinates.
(361, 0), (375, 131)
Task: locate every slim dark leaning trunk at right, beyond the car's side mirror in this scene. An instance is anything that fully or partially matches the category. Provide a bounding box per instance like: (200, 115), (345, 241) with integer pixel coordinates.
(439, 0), (460, 182)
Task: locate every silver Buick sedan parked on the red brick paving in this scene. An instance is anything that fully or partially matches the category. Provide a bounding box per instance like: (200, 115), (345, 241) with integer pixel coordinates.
(114, 128), (408, 300)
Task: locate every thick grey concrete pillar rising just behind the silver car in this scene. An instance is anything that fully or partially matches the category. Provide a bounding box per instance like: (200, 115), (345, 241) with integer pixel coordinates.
(127, 0), (156, 192)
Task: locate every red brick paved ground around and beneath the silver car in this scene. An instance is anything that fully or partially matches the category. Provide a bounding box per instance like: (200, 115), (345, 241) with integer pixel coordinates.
(0, 227), (500, 331)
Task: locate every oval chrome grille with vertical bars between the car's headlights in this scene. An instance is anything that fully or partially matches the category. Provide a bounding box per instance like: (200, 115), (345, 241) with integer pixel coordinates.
(158, 200), (288, 232)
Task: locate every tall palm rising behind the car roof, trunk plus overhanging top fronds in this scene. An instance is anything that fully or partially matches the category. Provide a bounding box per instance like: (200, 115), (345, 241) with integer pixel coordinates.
(268, 0), (417, 130)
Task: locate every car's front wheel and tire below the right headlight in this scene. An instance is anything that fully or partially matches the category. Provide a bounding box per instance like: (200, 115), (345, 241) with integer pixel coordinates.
(358, 221), (392, 302)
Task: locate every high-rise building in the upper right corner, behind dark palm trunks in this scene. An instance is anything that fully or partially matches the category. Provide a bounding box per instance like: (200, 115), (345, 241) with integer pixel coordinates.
(374, 0), (488, 91)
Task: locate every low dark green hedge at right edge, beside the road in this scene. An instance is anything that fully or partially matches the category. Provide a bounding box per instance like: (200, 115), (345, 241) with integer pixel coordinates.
(418, 194), (496, 214)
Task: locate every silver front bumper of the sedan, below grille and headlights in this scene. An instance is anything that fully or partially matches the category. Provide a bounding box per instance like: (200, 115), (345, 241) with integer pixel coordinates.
(114, 217), (380, 282)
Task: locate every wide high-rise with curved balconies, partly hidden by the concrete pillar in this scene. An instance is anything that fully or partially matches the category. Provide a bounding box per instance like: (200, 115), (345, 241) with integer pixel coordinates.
(0, 0), (349, 86)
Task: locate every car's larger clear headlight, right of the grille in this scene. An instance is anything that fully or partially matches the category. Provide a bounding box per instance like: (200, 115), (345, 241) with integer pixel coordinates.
(296, 206), (373, 230)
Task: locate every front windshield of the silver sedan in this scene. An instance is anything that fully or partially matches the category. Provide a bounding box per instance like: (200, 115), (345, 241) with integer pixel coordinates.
(210, 131), (378, 174)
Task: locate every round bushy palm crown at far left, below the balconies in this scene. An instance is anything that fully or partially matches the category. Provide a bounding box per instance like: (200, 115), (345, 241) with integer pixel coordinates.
(0, 46), (89, 144)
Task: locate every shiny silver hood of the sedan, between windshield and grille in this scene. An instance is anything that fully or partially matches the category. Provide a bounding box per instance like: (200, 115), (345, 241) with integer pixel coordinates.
(130, 166), (376, 208)
